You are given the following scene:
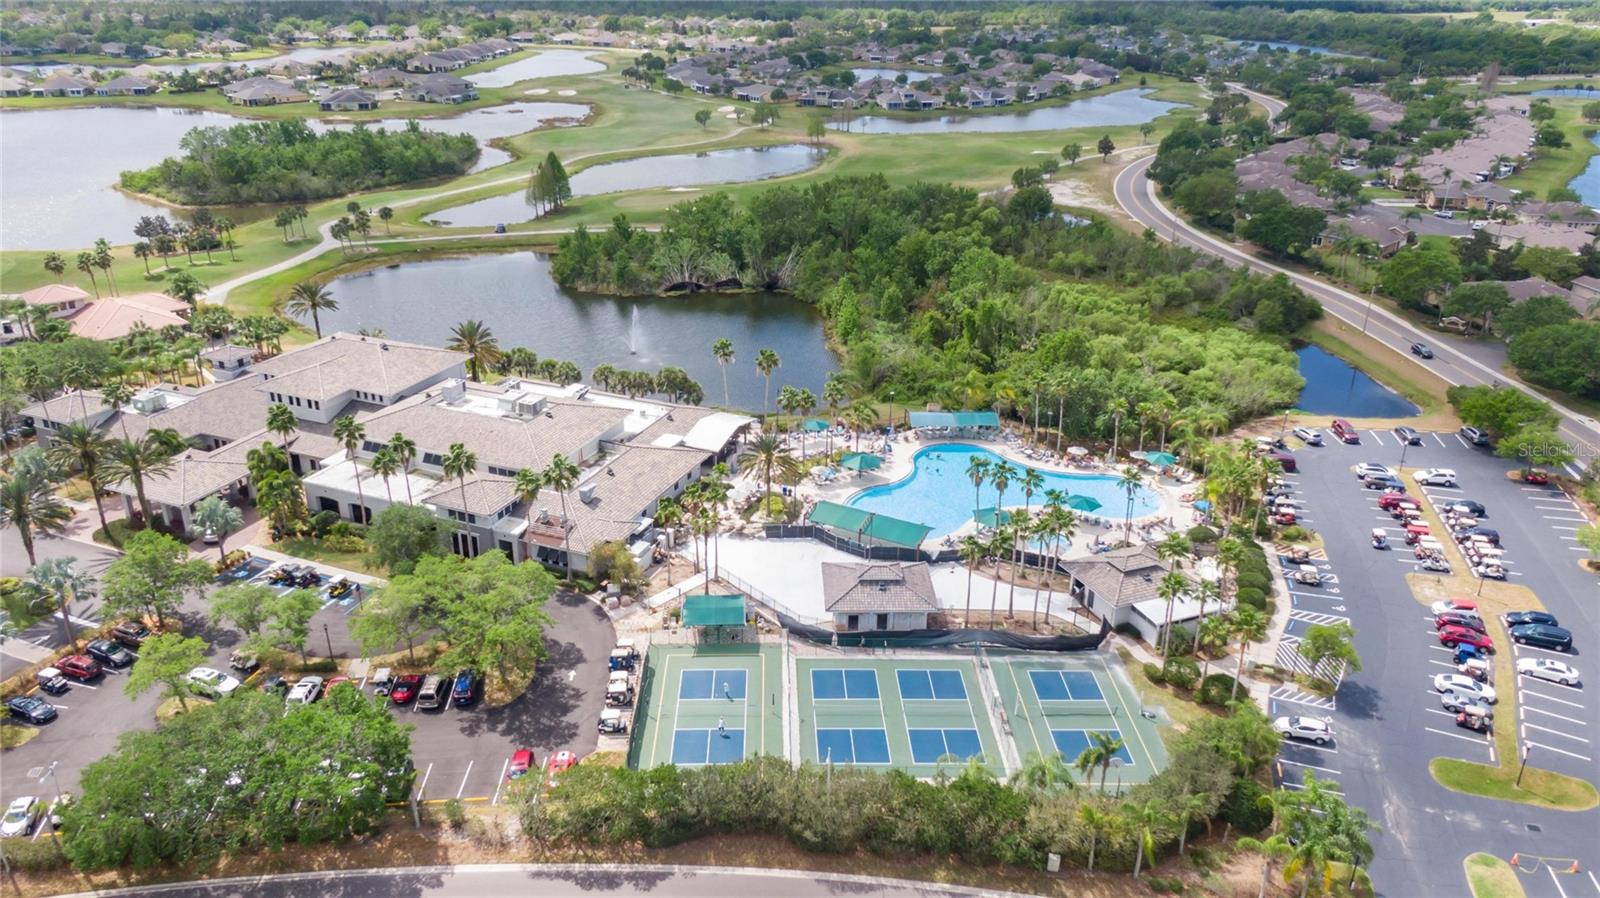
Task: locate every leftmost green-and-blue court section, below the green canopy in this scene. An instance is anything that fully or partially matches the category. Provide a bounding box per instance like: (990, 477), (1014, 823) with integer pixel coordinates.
(629, 645), (784, 768)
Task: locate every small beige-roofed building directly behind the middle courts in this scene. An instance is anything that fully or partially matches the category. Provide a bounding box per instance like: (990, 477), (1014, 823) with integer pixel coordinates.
(822, 562), (939, 632)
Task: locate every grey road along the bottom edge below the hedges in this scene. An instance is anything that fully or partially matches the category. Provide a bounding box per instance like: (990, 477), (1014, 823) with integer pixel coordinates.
(67, 864), (1014, 898)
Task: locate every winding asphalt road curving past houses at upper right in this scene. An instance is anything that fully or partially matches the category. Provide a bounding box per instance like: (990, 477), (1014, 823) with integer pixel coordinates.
(1112, 91), (1600, 469)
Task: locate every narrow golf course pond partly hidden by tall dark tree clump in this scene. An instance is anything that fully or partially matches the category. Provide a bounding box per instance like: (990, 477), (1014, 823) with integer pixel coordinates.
(427, 144), (826, 227)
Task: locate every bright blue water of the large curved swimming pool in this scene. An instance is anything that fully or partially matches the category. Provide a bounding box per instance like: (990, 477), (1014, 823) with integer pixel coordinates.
(848, 443), (1162, 536)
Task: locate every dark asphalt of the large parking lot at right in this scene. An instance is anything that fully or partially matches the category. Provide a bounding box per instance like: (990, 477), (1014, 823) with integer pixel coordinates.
(1270, 431), (1600, 898)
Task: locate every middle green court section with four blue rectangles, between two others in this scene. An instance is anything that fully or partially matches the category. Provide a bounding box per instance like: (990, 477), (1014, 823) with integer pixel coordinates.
(795, 658), (1002, 776)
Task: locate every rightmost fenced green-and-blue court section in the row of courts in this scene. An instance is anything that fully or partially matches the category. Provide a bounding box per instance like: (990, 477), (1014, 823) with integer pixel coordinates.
(989, 653), (1166, 788)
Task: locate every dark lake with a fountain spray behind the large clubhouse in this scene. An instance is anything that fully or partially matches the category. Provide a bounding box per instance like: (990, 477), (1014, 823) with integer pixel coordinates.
(322, 253), (838, 410)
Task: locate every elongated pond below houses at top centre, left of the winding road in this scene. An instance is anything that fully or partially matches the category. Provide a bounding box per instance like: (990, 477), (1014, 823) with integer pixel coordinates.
(832, 90), (1182, 134)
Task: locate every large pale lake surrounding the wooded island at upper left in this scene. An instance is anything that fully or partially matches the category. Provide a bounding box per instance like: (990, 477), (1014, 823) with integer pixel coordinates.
(0, 102), (589, 250)
